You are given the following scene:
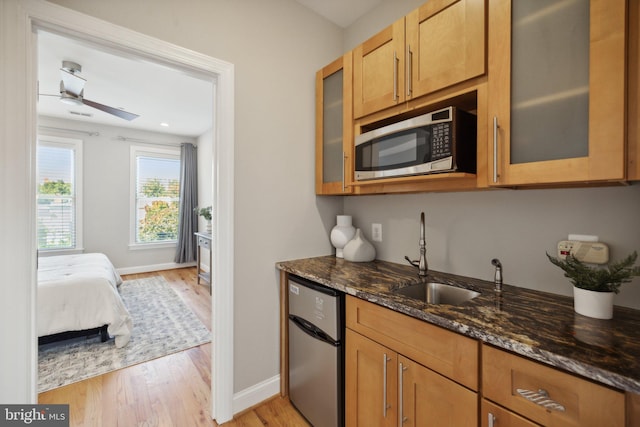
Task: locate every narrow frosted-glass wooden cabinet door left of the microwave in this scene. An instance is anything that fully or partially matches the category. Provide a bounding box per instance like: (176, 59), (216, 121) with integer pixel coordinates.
(316, 52), (353, 195)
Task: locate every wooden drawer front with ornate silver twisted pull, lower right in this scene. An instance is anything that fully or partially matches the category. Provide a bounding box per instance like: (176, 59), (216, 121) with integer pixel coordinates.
(482, 345), (625, 427)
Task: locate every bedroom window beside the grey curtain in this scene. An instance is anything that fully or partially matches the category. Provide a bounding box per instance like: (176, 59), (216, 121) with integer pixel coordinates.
(131, 146), (180, 246)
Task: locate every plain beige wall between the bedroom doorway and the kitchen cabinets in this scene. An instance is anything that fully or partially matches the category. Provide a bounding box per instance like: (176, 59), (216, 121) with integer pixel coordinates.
(43, 0), (343, 392)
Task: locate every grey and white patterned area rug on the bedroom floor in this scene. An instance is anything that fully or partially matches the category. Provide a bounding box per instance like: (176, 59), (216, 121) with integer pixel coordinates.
(38, 276), (211, 392)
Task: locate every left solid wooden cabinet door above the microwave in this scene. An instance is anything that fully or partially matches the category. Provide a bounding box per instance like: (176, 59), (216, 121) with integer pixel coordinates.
(353, 18), (405, 118)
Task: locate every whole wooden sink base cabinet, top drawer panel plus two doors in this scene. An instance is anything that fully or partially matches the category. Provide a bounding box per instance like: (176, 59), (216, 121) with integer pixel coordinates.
(345, 297), (478, 427)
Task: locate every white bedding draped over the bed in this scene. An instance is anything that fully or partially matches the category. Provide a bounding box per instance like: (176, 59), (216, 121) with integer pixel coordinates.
(36, 253), (133, 347)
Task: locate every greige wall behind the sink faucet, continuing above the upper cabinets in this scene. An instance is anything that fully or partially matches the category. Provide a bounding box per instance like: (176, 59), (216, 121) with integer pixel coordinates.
(344, 0), (640, 309)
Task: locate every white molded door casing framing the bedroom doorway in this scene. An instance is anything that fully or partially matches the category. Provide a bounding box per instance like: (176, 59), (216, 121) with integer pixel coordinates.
(0, 0), (235, 424)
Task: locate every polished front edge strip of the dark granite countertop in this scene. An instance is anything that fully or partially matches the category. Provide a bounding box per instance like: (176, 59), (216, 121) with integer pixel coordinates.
(276, 260), (640, 394)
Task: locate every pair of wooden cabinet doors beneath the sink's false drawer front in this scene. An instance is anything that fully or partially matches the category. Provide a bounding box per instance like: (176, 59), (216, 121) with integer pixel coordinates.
(346, 329), (478, 427)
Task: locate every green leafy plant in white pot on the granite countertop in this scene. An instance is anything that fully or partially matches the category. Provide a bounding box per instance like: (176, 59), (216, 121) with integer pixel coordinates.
(547, 251), (640, 319)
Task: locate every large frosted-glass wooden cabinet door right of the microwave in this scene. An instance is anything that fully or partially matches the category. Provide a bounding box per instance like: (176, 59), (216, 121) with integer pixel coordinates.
(487, 0), (626, 186)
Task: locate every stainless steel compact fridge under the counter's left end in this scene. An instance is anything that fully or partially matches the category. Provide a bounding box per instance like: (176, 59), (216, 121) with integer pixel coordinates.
(289, 276), (344, 427)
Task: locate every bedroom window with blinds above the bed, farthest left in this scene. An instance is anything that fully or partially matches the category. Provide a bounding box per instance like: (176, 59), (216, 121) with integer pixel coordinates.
(36, 137), (82, 250)
